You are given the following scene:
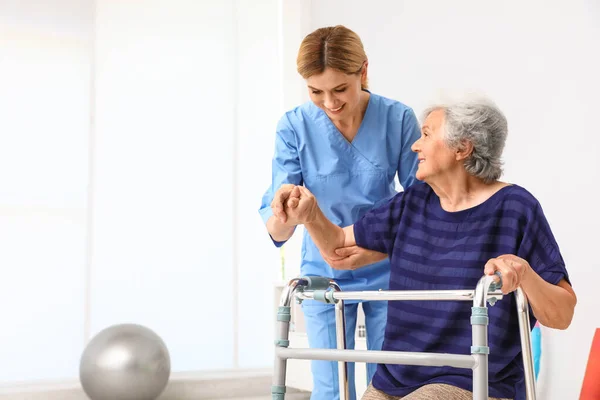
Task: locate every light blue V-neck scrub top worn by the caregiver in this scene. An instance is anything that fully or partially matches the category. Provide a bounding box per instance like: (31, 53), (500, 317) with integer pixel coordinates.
(259, 93), (421, 290)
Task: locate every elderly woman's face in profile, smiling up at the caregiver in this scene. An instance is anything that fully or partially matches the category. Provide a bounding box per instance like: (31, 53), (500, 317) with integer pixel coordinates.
(412, 110), (460, 182)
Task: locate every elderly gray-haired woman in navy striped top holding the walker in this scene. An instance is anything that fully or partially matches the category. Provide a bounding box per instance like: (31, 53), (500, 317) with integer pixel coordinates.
(274, 101), (577, 400)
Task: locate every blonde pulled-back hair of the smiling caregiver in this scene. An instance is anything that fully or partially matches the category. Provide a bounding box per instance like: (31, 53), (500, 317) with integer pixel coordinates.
(296, 25), (368, 89)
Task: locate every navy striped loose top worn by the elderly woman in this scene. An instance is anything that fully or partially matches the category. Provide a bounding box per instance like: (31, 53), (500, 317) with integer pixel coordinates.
(354, 183), (568, 400)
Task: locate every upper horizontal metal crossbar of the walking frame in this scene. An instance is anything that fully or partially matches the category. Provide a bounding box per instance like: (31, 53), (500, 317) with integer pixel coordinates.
(296, 290), (503, 301)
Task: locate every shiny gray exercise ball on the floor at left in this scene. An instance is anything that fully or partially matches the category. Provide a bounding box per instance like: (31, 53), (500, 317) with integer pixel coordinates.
(79, 324), (171, 400)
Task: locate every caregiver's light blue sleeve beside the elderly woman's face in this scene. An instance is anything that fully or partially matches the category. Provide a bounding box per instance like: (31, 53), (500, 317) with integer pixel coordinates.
(398, 108), (421, 190)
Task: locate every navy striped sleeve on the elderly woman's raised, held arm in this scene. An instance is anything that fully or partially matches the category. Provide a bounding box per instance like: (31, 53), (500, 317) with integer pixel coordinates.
(354, 192), (404, 255)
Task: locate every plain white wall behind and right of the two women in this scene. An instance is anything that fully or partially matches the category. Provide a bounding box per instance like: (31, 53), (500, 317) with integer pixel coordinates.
(305, 0), (600, 400)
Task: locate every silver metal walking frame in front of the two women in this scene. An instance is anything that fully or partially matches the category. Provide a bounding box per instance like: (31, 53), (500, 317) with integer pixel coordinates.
(271, 276), (536, 400)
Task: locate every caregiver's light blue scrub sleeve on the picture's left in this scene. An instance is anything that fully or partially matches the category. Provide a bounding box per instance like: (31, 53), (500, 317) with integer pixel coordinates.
(258, 115), (303, 247)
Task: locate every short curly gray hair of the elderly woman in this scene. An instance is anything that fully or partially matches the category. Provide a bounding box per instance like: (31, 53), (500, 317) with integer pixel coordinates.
(423, 99), (508, 183)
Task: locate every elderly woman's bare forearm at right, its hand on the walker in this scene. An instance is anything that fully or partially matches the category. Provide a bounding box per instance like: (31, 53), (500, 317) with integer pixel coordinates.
(521, 269), (577, 329)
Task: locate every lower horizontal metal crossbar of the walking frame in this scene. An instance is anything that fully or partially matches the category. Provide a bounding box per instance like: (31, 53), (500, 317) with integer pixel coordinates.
(275, 347), (478, 368)
